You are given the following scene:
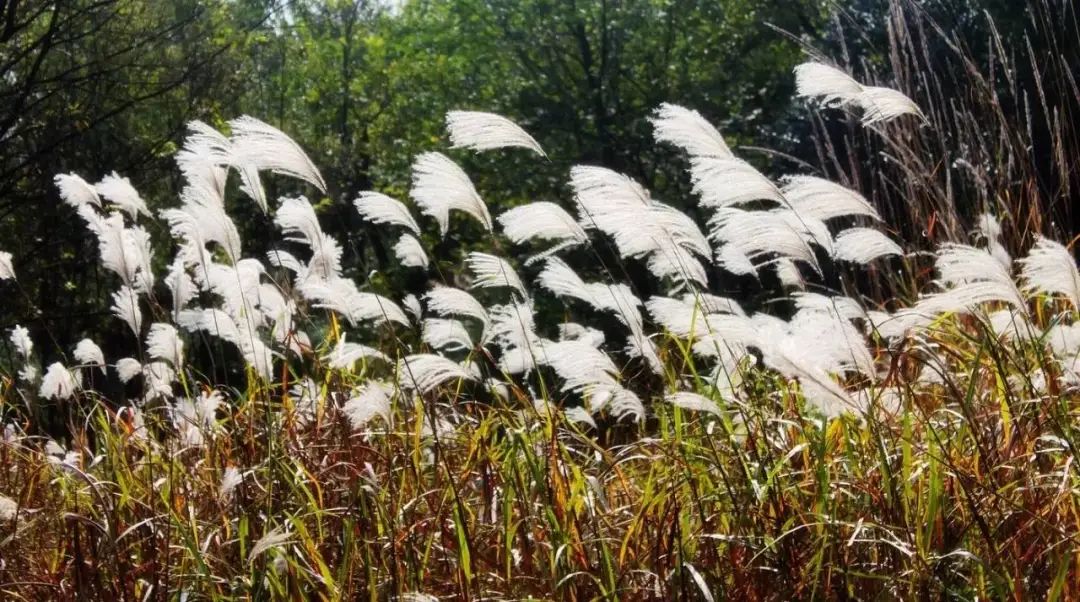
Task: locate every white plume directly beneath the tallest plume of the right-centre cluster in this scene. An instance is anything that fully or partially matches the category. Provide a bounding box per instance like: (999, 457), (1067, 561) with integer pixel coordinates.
(690, 157), (784, 209)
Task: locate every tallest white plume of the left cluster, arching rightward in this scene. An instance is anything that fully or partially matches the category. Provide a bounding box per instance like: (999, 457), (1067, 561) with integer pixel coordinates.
(229, 116), (326, 212)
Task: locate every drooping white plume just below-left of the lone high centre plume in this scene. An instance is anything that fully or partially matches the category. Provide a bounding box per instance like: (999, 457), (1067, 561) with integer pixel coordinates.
(409, 152), (491, 236)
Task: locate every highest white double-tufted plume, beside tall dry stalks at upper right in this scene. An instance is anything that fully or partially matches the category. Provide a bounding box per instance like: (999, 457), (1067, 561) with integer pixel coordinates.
(795, 62), (924, 125)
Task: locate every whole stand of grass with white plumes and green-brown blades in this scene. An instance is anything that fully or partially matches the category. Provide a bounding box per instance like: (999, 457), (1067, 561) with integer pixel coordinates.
(0, 54), (1080, 600)
